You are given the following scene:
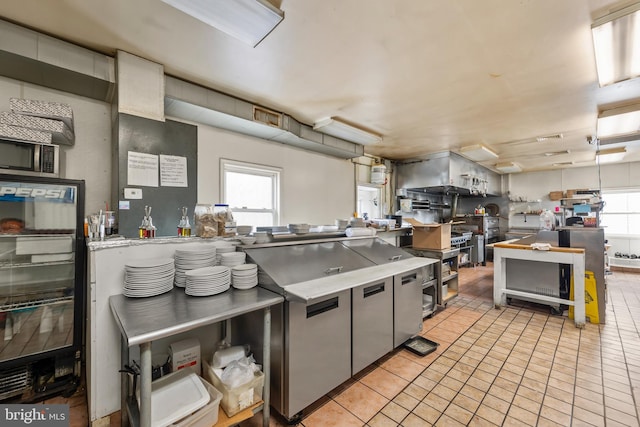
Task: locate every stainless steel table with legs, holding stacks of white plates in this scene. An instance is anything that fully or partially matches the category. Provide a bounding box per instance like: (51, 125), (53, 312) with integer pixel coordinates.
(109, 287), (284, 427)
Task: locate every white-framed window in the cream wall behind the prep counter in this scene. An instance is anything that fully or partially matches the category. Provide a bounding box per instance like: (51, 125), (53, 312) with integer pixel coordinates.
(220, 159), (282, 227)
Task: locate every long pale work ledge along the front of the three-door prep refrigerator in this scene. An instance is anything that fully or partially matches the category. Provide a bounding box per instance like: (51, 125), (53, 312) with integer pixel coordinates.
(285, 257), (438, 303)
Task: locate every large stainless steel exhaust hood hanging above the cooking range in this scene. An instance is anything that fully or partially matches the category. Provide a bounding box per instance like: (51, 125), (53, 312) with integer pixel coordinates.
(395, 151), (502, 196)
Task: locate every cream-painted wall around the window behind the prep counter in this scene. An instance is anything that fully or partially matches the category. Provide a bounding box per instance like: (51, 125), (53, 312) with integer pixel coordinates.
(186, 119), (356, 225)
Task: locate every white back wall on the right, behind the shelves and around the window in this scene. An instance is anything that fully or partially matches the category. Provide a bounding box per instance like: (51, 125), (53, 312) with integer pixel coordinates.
(508, 162), (640, 254)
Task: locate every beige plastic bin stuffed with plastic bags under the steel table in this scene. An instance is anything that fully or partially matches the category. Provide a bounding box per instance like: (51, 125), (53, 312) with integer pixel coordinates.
(203, 360), (264, 417)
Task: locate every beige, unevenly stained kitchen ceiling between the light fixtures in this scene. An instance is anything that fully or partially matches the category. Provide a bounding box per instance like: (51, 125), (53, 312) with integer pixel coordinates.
(0, 0), (640, 171)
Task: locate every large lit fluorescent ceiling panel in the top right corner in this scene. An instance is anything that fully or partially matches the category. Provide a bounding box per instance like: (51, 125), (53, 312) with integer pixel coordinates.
(591, 3), (640, 86)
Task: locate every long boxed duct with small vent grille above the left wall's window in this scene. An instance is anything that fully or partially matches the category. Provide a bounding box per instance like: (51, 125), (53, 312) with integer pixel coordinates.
(164, 76), (364, 159)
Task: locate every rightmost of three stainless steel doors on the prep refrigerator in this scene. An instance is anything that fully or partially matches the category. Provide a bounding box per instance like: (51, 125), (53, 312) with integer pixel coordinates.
(393, 268), (425, 348)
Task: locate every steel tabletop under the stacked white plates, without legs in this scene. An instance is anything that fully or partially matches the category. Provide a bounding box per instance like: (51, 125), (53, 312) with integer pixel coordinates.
(109, 287), (284, 346)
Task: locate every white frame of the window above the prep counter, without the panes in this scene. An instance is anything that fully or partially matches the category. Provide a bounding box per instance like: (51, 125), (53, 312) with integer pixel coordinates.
(220, 159), (282, 226)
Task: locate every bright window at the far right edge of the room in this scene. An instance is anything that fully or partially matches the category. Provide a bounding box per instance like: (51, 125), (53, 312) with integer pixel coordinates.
(600, 190), (640, 236)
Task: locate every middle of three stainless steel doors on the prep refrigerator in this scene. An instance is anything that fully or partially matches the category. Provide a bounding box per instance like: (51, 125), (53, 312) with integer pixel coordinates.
(351, 277), (393, 375)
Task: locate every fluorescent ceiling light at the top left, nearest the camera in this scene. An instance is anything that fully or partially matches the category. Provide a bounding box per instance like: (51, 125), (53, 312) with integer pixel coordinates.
(162, 0), (284, 47)
